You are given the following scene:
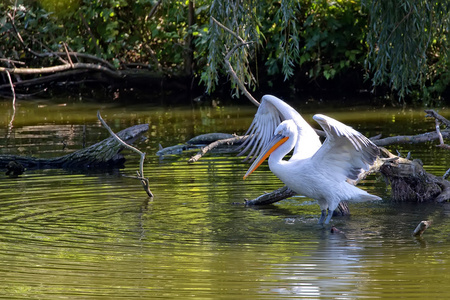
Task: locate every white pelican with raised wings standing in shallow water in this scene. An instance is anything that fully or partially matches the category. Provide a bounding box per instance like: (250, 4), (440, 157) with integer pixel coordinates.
(239, 95), (381, 224)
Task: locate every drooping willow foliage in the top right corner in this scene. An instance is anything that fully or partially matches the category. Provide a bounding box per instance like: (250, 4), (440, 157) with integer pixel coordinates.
(363, 0), (450, 98)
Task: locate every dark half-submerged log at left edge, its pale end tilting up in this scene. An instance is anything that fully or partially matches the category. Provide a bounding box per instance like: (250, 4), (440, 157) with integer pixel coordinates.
(0, 124), (149, 169)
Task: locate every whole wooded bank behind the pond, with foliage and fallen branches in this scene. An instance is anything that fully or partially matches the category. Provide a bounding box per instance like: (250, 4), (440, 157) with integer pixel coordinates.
(0, 0), (450, 105)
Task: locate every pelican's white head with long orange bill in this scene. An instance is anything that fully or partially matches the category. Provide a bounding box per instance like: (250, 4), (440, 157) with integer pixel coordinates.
(244, 120), (298, 180)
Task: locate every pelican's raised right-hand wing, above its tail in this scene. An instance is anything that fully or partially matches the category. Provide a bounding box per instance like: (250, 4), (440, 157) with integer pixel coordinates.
(311, 114), (380, 181)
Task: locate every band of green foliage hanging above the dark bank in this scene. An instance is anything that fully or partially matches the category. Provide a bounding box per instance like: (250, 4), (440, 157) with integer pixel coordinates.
(0, 0), (450, 101)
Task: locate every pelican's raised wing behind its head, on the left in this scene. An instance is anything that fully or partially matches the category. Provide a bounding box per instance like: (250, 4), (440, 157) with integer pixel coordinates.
(238, 95), (320, 161)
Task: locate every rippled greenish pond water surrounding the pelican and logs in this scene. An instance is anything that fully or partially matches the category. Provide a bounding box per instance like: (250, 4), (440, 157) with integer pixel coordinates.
(0, 98), (450, 299)
